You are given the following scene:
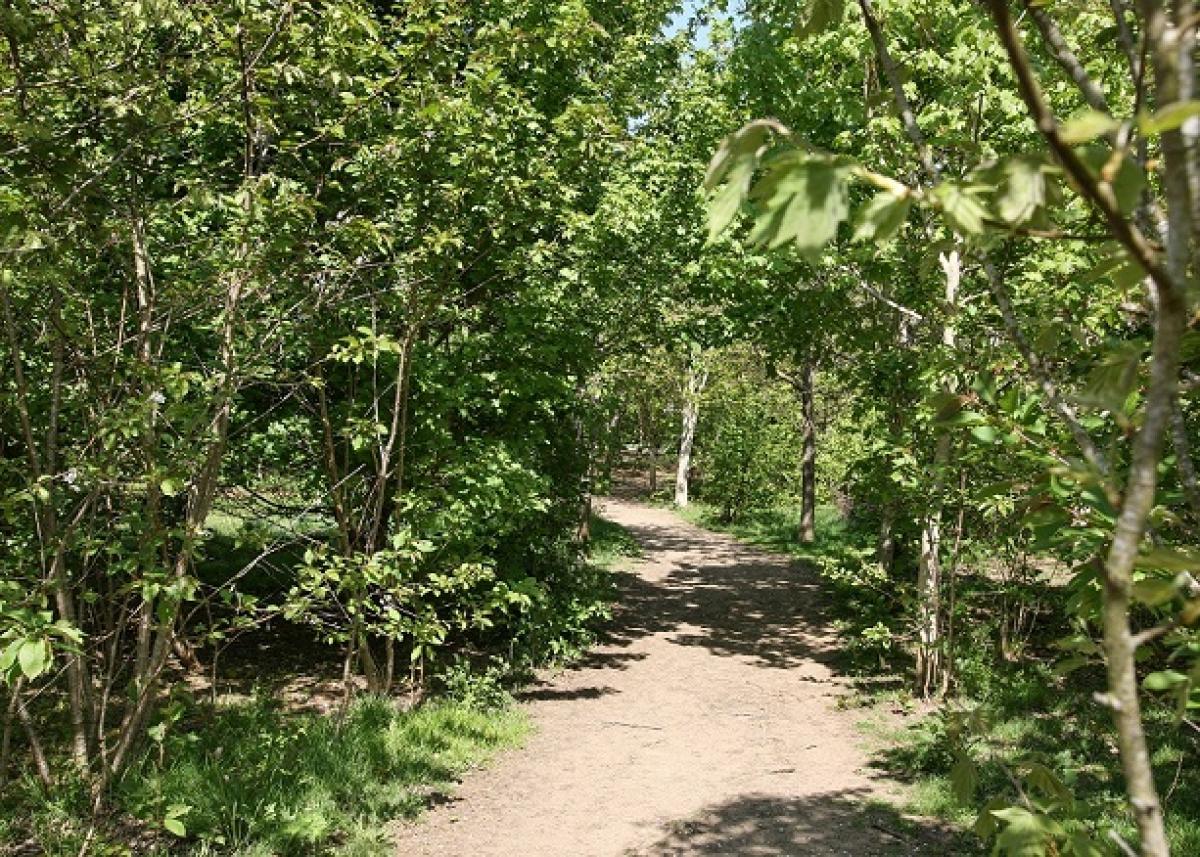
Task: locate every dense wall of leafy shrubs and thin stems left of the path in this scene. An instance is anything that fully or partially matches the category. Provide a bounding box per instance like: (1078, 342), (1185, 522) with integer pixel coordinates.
(0, 0), (676, 840)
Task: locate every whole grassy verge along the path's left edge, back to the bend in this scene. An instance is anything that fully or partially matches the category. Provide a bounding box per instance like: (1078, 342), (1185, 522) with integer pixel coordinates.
(0, 517), (637, 857)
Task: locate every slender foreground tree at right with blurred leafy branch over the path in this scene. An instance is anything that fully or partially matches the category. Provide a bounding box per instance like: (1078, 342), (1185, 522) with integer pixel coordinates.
(710, 0), (1193, 855)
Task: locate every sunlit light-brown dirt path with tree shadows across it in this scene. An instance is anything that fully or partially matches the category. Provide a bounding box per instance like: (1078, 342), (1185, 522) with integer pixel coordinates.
(397, 499), (944, 857)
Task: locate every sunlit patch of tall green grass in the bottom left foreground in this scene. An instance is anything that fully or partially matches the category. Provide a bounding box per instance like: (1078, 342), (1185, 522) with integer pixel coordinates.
(7, 697), (528, 857)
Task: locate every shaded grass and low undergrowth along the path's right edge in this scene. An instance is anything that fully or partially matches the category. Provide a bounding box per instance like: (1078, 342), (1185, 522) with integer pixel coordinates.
(680, 503), (1200, 855)
